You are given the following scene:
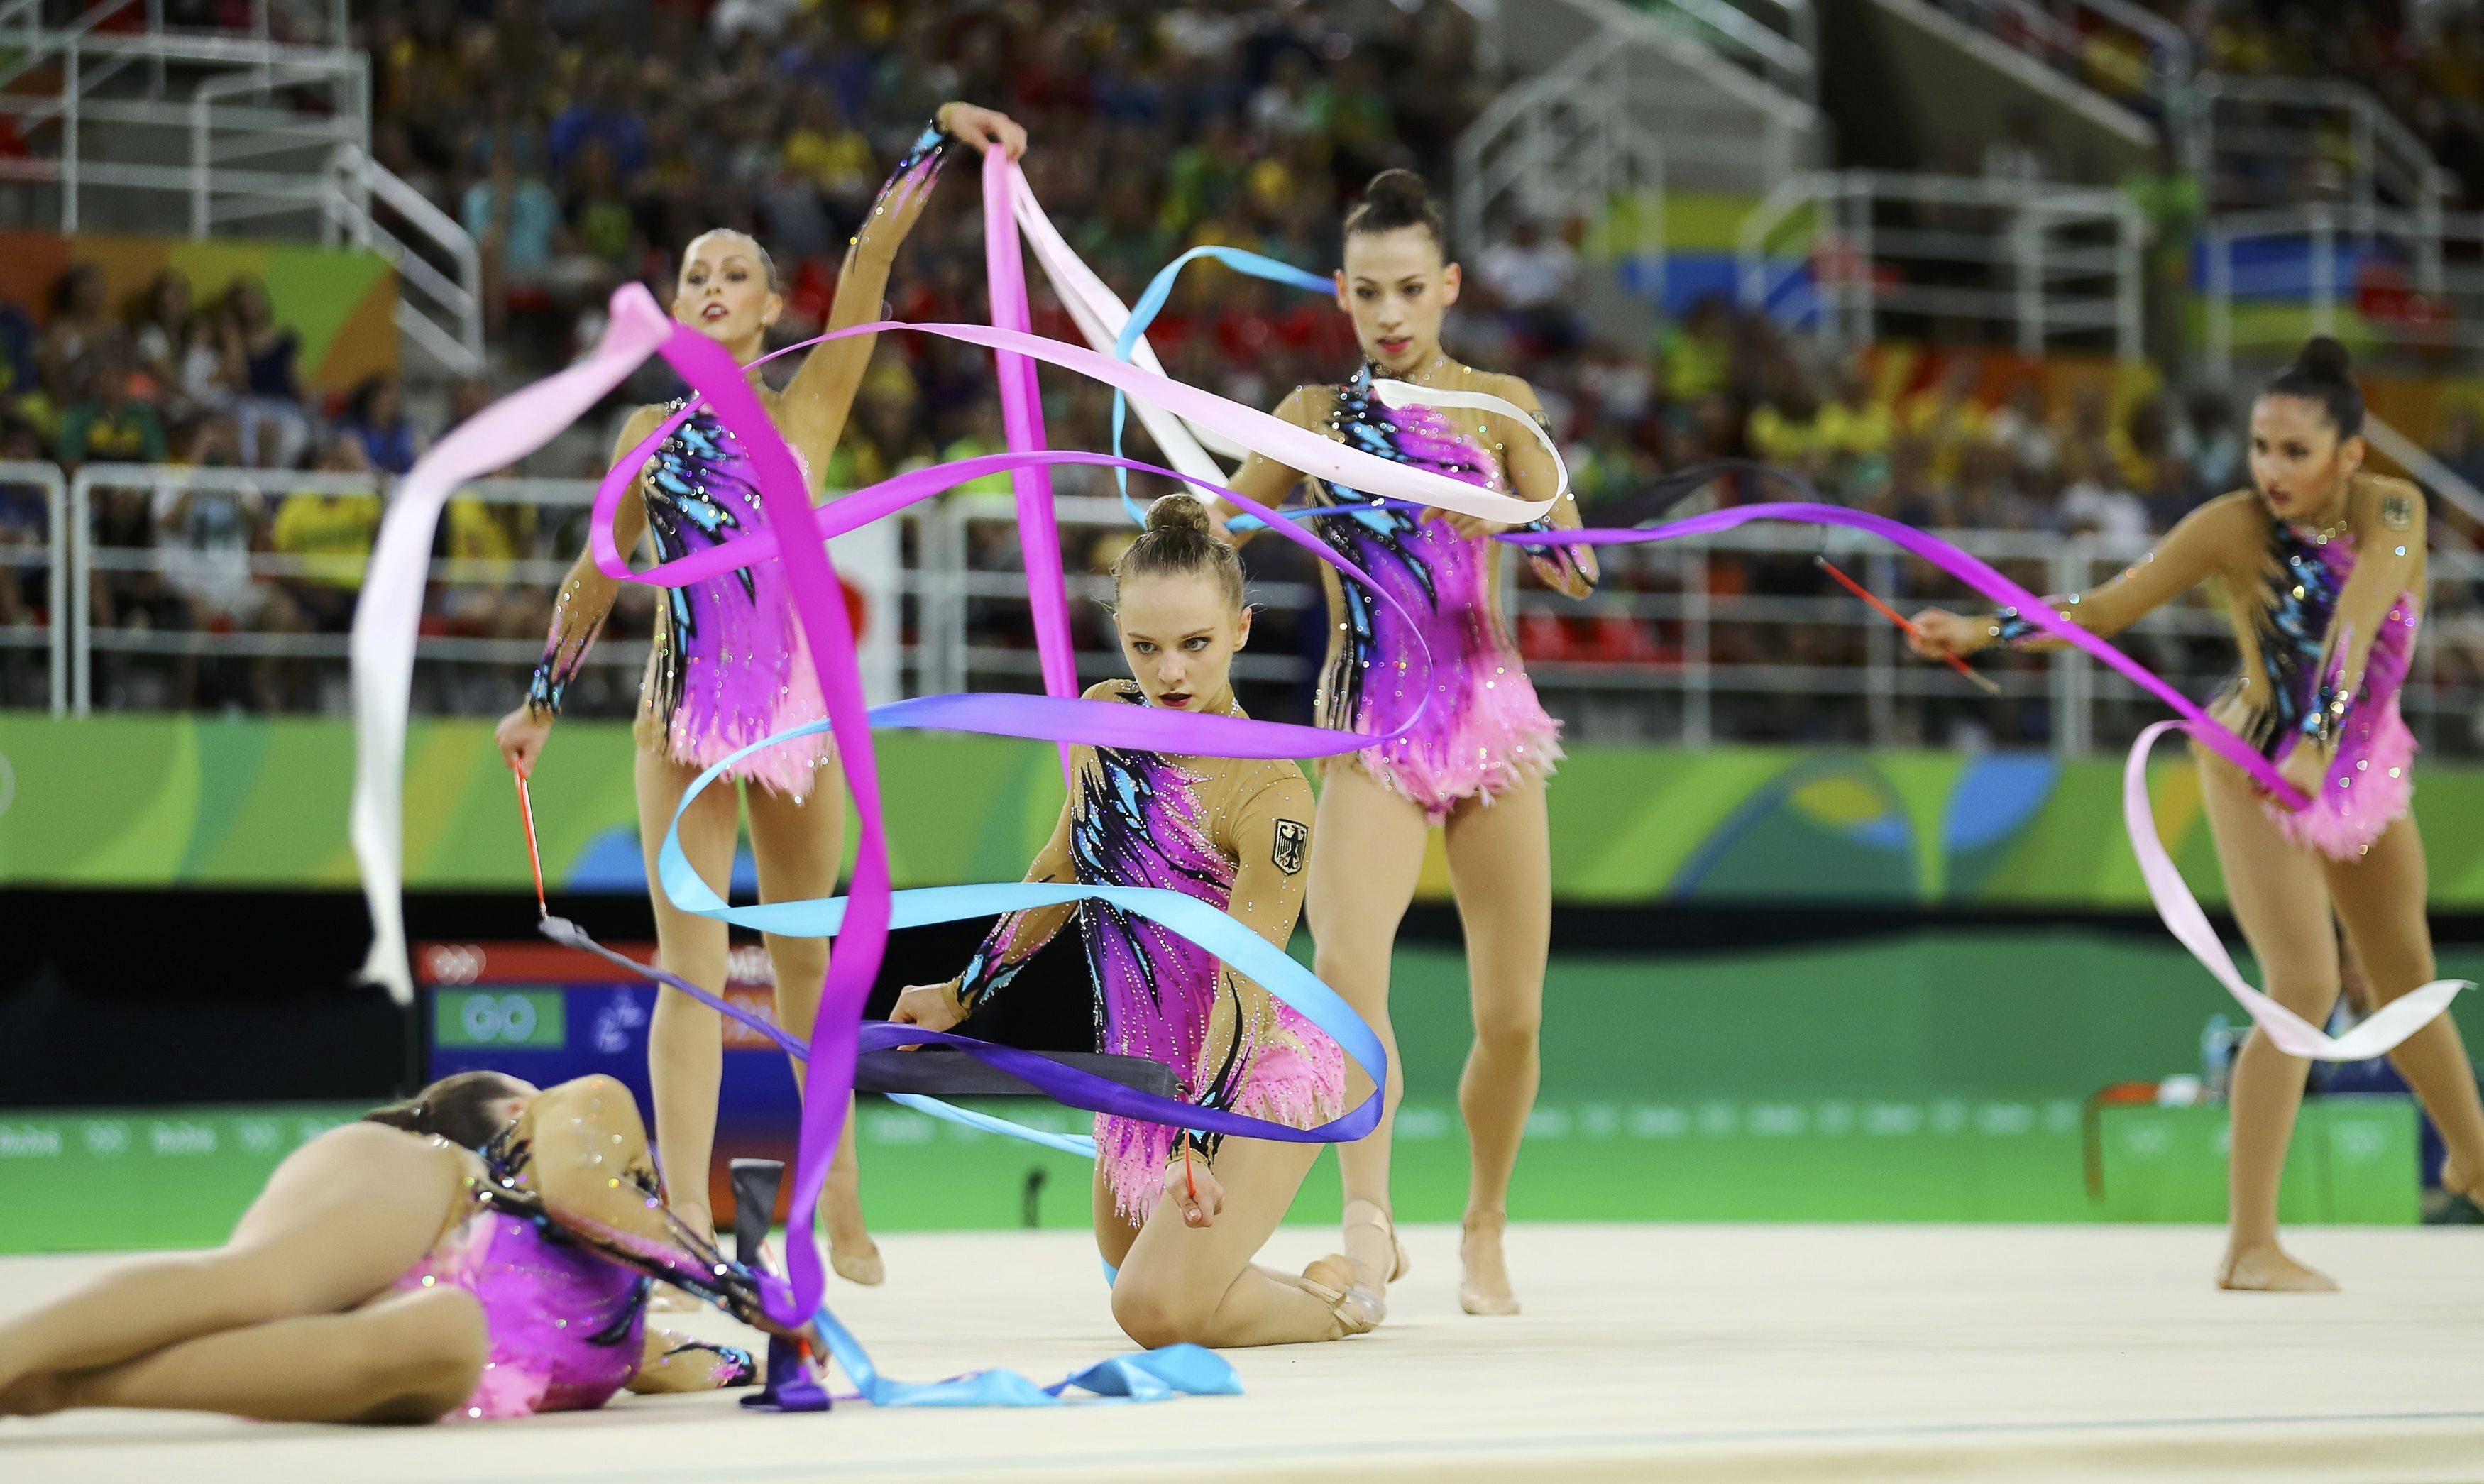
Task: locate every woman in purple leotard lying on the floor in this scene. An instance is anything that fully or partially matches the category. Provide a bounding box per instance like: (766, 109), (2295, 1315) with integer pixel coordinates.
(0, 1072), (815, 1422)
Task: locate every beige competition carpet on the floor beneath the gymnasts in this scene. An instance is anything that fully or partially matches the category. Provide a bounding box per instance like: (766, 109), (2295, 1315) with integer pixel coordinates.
(0, 1226), (2484, 1484)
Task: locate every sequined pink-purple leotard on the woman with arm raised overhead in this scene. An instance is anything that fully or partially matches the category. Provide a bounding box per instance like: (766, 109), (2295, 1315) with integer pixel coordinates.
(527, 402), (832, 798)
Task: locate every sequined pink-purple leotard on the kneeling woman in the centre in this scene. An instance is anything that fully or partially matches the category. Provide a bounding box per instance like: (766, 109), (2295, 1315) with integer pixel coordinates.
(959, 681), (1344, 1221)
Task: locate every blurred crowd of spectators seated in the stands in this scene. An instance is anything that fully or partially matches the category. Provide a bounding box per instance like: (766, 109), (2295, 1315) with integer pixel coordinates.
(0, 0), (2484, 736)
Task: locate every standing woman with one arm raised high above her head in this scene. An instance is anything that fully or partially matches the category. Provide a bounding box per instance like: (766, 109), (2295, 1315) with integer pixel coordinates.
(497, 102), (1026, 1282)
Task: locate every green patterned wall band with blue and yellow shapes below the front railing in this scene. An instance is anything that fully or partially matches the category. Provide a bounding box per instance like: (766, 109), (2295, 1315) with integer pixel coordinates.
(14, 713), (2484, 912)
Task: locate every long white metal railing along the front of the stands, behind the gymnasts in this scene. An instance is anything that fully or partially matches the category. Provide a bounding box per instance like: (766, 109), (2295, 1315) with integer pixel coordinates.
(50, 465), (2484, 756)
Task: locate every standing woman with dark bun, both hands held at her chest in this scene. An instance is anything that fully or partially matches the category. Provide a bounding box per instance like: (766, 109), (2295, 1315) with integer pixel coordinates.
(1220, 169), (1595, 1322)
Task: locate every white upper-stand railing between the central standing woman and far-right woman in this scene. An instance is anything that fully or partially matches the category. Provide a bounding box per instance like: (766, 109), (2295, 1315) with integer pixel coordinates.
(1737, 169), (2146, 356)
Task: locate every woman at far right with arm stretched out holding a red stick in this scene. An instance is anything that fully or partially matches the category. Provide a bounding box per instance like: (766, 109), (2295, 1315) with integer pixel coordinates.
(1916, 336), (2484, 1292)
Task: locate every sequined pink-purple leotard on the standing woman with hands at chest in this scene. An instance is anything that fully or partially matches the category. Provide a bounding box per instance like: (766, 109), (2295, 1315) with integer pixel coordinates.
(1312, 365), (1588, 820)
